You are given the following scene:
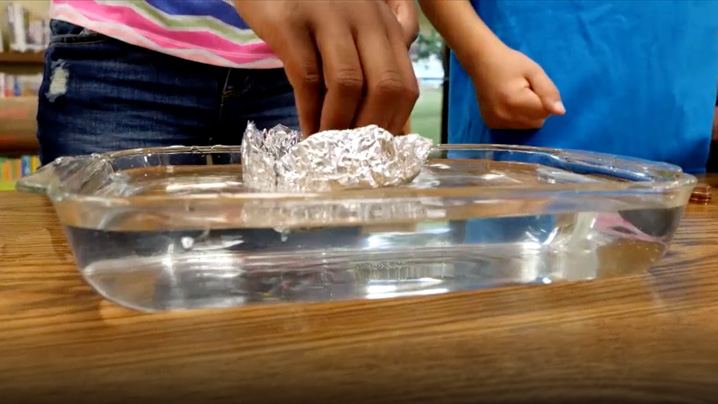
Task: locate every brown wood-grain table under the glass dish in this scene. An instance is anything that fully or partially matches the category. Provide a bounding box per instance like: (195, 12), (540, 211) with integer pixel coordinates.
(0, 177), (718, 404)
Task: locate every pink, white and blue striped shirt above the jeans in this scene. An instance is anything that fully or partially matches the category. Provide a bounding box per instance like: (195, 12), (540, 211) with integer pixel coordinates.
(50, 0), (282, 69)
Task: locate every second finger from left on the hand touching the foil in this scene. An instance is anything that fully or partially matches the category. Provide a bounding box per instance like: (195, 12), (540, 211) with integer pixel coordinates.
(317, 26), (364, 130)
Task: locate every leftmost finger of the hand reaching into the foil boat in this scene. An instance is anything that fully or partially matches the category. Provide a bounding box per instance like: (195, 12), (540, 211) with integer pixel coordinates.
(283, 28), (324, 136)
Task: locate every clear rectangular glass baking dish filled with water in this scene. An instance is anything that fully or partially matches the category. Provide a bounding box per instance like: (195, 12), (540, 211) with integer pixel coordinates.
(18, 145), (696, 311)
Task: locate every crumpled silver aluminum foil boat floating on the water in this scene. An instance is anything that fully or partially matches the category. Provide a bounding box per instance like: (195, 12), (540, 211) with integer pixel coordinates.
(242, 123), (432, 192)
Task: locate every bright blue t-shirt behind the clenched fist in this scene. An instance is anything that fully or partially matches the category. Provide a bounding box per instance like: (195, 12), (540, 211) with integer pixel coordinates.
(449, 0), (718, 172)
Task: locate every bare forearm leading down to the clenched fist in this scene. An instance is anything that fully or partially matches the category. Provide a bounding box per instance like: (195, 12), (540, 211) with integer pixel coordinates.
(419, 0), (505, 69)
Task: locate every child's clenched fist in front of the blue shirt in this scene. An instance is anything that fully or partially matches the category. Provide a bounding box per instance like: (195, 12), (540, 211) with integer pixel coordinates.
(467, 46), (566, 129)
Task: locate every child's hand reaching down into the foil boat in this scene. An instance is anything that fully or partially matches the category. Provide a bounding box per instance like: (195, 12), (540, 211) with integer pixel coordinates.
(234, 0), (419, 135)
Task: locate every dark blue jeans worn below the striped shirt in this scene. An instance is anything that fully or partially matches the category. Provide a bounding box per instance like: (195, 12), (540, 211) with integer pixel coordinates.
(37, 20), (298, 164)
